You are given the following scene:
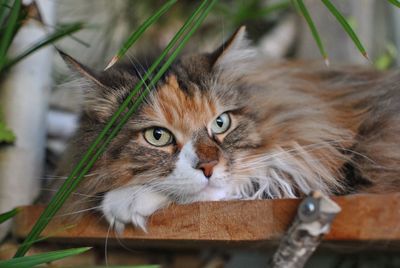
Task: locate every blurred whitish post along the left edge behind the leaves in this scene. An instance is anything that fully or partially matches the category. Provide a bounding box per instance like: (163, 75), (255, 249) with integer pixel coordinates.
(0, 0), (55, 240)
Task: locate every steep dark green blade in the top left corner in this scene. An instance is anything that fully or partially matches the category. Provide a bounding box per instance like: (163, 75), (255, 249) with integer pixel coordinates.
(0, 0), (21, 73)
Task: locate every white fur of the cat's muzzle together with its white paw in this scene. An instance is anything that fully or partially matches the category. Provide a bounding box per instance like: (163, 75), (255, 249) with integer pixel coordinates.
(101, 142), (231, 232)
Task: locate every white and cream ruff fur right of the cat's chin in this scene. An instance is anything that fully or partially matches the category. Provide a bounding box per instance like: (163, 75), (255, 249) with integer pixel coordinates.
(234, 144), (340, 199)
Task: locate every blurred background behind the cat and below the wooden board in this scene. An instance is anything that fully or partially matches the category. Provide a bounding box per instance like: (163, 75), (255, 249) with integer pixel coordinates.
(0, 0), (400, 267)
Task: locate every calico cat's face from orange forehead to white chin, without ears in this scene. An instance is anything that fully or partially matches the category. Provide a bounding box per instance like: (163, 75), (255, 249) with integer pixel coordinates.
(121, 71), (258, 202)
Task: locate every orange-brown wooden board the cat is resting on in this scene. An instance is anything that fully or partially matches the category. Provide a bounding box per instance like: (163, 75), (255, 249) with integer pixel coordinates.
(14, 193), (400, 247)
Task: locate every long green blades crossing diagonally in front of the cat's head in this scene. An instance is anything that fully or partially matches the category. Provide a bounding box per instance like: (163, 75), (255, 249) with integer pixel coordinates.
(15, 0), (217, 257)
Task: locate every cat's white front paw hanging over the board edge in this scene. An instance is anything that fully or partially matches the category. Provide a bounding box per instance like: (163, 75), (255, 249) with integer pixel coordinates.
(101, 186), (169, 233)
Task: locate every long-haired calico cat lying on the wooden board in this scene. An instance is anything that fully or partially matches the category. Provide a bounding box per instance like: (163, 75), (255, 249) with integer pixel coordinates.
(55, 27), (400, 229)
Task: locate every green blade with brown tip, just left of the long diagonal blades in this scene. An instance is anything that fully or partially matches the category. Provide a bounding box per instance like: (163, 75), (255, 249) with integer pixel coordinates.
(105, 0), (177, 70)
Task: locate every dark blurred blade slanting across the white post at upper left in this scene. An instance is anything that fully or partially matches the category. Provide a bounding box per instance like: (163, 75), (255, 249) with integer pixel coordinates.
(4, 22), (84, 69)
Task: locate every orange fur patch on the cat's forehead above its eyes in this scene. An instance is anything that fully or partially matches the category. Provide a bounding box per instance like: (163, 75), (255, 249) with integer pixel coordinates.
(142, 74), (219, 139)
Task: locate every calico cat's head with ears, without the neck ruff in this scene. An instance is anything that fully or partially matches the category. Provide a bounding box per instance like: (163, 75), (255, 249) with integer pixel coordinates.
(61, 27), (272, 203)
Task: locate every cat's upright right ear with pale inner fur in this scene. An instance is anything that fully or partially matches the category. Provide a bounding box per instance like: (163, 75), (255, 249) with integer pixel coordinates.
(210, 26), (256, 70)
